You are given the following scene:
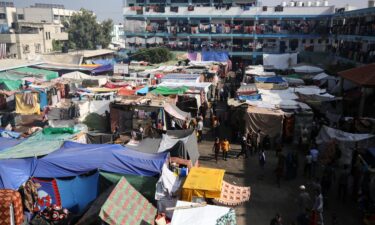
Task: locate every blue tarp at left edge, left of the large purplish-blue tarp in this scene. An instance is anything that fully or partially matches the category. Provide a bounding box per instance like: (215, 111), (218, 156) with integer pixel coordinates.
(0, 158), (36, 190)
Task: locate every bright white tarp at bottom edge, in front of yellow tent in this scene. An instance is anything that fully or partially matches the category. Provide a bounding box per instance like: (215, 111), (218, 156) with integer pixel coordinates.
(171, 201), (234, 225)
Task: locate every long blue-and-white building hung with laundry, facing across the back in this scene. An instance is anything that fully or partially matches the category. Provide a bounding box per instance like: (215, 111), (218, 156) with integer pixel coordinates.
(123, 0), (335, 61)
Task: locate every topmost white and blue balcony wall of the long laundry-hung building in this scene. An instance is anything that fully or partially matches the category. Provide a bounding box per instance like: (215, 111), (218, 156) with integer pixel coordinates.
(123, 6), (334, 19)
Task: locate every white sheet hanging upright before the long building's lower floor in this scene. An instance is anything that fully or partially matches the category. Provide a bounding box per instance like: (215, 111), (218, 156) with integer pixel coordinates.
(263, 53), (298, 70)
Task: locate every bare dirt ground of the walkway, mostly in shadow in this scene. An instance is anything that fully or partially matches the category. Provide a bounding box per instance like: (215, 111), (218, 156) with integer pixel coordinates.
(199, 104), (362, 225)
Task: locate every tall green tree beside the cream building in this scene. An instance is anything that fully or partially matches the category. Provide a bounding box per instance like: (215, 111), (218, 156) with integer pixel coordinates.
(64, 9), (113, 49)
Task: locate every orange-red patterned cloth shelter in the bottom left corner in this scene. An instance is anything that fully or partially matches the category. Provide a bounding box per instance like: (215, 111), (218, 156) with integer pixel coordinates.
(0, 190), (24, 225)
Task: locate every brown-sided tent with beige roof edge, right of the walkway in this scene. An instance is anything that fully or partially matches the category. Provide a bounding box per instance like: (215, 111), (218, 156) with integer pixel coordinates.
(245, 106), (284, 137)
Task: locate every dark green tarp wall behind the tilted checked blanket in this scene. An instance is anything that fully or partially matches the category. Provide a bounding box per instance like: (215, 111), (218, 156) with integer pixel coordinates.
(99, 171), (158, 203)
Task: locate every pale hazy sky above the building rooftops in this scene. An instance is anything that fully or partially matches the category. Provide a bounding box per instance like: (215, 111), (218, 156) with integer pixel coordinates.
(14, 0), (367, 23)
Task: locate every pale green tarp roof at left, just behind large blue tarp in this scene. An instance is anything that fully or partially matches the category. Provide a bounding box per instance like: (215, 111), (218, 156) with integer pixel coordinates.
(0, 131), (74, 159)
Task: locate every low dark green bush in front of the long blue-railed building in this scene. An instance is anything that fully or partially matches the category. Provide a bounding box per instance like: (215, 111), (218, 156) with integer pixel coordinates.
(130, 48), (173, 63)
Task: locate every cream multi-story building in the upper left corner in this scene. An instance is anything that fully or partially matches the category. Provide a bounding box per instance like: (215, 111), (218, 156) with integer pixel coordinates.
(0, 3), (77, 59)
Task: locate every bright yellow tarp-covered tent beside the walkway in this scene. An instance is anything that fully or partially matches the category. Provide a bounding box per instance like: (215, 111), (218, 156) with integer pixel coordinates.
(182, 167), (225, 202)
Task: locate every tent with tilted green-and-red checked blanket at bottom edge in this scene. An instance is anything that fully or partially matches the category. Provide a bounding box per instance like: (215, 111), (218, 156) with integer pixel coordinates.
(77, 178), (156, 225)
